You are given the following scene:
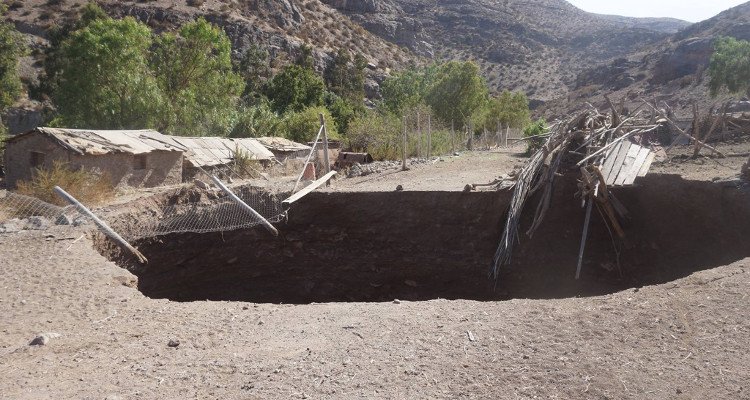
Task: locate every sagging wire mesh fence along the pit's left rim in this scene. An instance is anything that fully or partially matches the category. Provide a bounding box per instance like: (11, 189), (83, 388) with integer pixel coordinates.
(0, 181), (294, 241)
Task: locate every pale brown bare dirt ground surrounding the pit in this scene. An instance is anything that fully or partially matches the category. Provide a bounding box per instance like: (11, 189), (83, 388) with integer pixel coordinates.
(0, 143), (750, 399)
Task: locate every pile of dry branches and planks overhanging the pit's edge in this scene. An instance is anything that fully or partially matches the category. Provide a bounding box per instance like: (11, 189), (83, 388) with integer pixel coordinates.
(490, 106), (669, 281)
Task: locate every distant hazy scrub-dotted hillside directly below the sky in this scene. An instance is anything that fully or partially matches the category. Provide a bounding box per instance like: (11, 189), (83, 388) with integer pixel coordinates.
(322, 0), (688, 101)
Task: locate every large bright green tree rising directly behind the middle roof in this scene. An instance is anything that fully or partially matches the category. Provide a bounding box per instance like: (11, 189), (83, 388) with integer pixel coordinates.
(152, 18), (244, 136)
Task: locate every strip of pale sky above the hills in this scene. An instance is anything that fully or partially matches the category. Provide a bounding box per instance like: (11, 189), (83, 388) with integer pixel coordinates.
(568, 0), (747, 22)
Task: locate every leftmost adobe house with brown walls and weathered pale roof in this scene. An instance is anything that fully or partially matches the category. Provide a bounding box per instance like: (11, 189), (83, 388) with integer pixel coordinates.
(5, 128), (185, 188)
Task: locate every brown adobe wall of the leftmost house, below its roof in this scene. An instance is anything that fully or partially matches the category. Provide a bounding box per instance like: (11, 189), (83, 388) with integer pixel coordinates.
(5, 133), (182, 189)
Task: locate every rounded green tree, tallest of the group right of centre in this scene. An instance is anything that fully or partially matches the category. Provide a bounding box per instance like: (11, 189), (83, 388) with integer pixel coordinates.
(426, 61), (488, 126)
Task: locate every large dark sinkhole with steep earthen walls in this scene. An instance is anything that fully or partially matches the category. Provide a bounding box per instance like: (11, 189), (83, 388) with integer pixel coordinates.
(98, 175), (750, 303)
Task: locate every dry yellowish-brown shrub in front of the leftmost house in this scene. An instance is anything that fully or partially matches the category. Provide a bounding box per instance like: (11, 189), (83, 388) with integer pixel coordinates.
(17, 161), (115, 206)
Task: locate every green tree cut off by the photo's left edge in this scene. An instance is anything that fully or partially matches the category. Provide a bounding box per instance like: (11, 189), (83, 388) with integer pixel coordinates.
(0, 3), (25, 111)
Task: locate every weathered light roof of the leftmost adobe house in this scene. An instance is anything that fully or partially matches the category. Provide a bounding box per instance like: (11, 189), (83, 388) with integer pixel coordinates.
(8, 128), (185, 155)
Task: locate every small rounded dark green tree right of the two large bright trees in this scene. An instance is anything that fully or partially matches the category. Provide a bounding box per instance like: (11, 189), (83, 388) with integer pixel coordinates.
(267, 65), (325, 113)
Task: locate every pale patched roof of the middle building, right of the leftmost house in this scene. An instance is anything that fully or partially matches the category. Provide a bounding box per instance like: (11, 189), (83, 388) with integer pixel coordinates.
(174, 137), (274, 167)
